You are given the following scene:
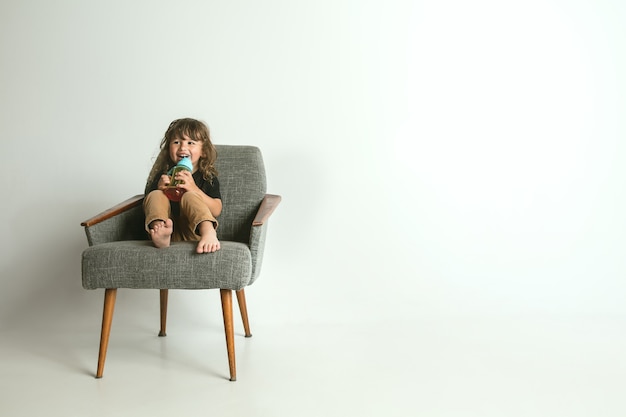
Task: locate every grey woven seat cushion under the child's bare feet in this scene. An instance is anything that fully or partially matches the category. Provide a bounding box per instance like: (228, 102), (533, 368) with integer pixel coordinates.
(82, 240), (252, 290)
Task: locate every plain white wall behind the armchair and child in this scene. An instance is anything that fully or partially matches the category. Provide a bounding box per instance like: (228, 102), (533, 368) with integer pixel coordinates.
(0, 0), (626, 326)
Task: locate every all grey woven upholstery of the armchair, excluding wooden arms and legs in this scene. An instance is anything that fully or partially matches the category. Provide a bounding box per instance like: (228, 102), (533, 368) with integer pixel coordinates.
(82, 145), (267, 290)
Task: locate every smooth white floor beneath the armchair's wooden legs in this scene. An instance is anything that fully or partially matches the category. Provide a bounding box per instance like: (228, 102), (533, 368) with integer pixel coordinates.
(0, 294), (626, 417)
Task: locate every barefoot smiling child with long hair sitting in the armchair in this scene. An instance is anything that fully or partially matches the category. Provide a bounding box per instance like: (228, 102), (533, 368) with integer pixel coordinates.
(143, 119), (222, 253)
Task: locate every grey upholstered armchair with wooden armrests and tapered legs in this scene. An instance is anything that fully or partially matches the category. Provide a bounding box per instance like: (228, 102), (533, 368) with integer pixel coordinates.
(82, 145), (281, 381)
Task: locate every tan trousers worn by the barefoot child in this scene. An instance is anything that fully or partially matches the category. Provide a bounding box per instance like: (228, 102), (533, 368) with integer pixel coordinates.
(143, 190), (217, 242)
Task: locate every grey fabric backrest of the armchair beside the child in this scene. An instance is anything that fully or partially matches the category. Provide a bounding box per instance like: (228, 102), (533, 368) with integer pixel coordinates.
(215, 145), (267, 243)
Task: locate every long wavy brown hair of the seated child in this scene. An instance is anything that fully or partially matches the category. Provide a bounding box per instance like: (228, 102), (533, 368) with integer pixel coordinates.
(146, 118), (217, 185)
